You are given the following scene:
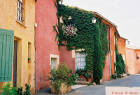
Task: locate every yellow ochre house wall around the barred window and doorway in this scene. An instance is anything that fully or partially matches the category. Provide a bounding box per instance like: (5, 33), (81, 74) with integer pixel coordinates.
(0, 0), (35, 91)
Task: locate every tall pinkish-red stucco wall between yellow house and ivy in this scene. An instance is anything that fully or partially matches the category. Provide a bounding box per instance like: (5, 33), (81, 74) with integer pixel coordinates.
(35, 0), (59, 90)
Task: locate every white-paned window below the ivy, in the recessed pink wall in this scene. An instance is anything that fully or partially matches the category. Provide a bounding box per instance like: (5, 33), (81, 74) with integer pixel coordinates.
(75, 51), (86, 70)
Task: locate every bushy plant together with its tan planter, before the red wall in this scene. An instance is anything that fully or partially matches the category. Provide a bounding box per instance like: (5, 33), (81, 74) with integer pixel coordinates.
(50, 64), (76, 94)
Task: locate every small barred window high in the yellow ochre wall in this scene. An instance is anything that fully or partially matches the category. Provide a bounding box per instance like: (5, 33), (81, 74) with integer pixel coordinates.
(17, 0), (24, 23)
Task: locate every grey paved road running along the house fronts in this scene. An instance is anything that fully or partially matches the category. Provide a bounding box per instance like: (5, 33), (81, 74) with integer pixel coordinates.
(36, 75), (140, 95)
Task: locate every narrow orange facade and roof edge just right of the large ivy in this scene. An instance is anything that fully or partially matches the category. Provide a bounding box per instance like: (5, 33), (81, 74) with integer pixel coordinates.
(93, 12), (117, 81)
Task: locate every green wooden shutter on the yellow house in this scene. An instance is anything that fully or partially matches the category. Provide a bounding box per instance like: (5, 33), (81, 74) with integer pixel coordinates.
(0, 29), (14, 82)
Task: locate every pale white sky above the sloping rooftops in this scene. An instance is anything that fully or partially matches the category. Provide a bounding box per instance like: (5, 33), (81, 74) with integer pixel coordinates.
(63, 0), (140, 47)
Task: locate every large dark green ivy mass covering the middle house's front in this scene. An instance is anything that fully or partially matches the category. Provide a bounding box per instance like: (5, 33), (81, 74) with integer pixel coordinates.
(54, 5), (108, 84)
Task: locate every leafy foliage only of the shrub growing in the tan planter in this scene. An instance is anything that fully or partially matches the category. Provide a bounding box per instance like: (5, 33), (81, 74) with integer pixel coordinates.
(50, 64), (77, 91)
